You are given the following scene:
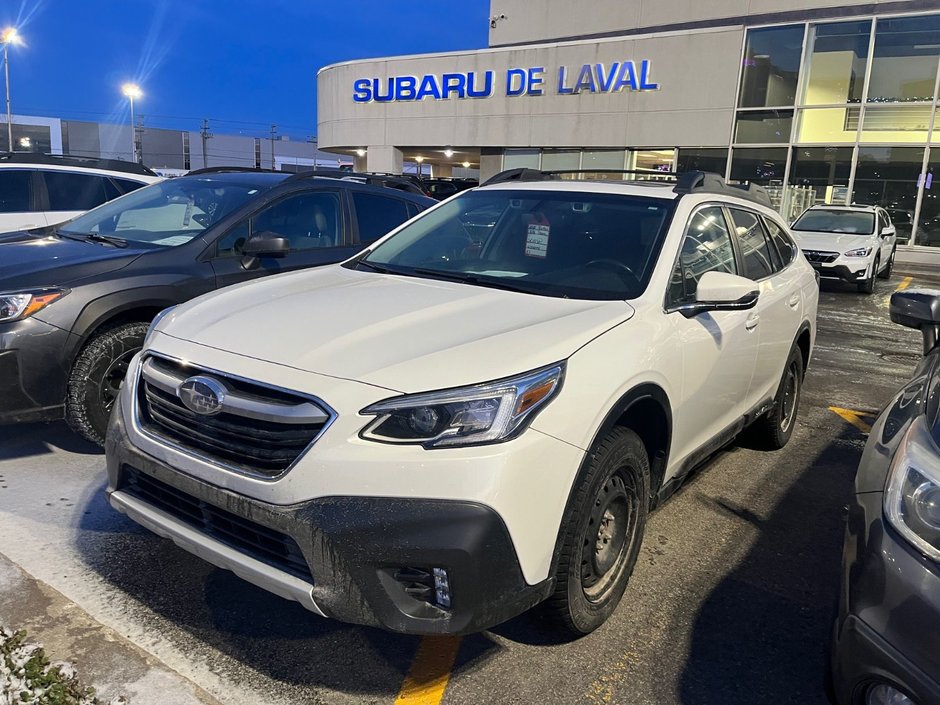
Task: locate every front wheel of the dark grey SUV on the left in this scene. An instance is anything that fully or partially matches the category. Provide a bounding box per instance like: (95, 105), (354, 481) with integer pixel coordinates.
(65, 323), (149, 446)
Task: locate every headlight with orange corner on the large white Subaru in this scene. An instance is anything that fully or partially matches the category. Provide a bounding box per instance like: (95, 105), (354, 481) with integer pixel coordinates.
(360, 363), (565, 448)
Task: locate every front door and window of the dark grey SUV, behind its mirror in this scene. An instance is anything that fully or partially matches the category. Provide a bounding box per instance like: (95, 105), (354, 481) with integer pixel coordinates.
(211, 188), (359, 287)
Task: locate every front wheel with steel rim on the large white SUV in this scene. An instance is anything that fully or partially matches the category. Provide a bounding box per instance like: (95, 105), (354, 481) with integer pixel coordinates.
(545, 427), (650, 638)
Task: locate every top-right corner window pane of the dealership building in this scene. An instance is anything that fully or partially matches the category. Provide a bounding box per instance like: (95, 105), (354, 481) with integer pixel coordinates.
(868, 15), (940, 103)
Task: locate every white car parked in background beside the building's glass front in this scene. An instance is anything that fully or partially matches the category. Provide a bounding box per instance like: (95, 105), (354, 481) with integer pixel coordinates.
(792, 205), (897, 294)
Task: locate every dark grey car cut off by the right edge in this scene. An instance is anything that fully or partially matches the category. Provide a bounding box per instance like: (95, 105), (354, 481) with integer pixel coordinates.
(832, 290), (940, 705)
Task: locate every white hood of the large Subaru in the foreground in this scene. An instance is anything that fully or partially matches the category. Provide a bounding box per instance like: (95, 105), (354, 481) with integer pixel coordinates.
(158, 265), (634, 392)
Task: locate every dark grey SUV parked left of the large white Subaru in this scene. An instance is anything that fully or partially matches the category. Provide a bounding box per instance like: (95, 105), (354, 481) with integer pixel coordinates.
(0, 168), (434, 444)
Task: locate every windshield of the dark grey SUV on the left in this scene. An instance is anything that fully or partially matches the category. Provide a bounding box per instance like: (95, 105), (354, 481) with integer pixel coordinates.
(59, 178), (266, 247)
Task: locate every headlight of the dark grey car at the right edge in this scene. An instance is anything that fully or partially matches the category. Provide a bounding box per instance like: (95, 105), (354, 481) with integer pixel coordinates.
(884, 416), (940, 561)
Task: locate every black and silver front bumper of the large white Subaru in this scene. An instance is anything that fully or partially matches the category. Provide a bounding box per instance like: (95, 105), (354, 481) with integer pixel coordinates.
(107, 394), (553, 634)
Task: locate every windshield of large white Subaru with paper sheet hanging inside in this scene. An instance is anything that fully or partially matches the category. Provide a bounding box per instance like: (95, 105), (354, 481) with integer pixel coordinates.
(349, 189), (673, 300)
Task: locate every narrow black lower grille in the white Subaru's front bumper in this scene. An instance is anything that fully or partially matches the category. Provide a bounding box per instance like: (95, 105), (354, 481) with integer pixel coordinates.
(119, 465), (313, 583)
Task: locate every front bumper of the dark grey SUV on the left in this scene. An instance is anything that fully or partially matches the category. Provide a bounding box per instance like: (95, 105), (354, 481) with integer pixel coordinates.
(0, 318), (70, 424)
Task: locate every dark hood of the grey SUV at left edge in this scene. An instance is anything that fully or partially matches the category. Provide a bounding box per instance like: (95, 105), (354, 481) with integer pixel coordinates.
(0, 232), (146, 289)
